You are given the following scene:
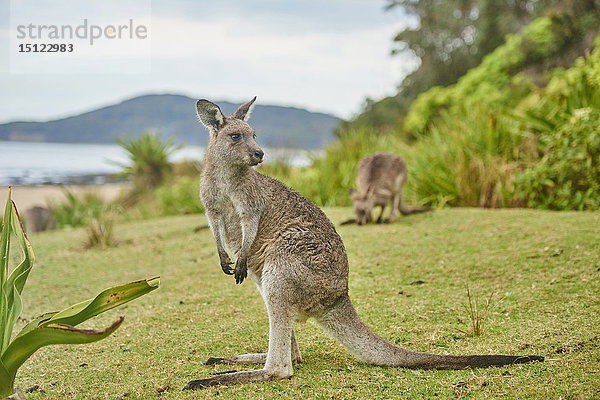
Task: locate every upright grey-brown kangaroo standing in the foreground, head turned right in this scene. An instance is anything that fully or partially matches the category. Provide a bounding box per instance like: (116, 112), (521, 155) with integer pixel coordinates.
(184, 98), (544, 389)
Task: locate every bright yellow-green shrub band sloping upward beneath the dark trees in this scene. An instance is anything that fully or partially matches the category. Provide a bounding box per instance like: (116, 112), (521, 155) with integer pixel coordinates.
(404, 14), (596, 134)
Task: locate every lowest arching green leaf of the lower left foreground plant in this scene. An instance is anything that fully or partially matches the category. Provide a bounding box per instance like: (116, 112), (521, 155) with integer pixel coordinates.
(2, 317), (124, 387)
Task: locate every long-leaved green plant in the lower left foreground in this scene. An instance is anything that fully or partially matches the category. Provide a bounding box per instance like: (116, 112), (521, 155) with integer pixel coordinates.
(0, 188), (159, 398)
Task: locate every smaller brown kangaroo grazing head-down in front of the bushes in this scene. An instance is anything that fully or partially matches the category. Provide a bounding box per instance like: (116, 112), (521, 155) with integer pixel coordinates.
(350, 153), (430, 225)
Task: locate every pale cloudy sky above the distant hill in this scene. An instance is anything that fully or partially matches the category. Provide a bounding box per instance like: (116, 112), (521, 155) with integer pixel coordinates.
(0, 0), (415, 122)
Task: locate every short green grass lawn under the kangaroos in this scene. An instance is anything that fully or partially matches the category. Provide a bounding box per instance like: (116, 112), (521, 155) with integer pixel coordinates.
(13, 208), (600, 400)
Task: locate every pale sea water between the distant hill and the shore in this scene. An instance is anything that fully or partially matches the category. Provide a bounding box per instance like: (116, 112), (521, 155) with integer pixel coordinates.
(0, 141), (310, 186)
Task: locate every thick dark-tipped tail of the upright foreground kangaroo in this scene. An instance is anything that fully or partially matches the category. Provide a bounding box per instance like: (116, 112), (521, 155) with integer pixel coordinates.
(318, 296), (544, 369)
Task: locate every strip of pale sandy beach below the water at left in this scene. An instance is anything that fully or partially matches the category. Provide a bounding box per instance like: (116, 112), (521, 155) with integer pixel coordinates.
(0, 183), (127, 212)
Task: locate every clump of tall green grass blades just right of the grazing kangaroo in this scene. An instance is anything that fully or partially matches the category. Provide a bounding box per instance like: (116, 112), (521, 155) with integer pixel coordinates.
(406, 106), (535, 207)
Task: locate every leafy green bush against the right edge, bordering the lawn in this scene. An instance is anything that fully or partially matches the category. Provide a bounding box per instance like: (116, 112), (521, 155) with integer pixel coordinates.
(517, 37), (600, 210)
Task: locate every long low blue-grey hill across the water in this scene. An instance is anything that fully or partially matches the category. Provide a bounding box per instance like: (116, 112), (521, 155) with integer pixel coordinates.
(0, 94), (339, 149)
